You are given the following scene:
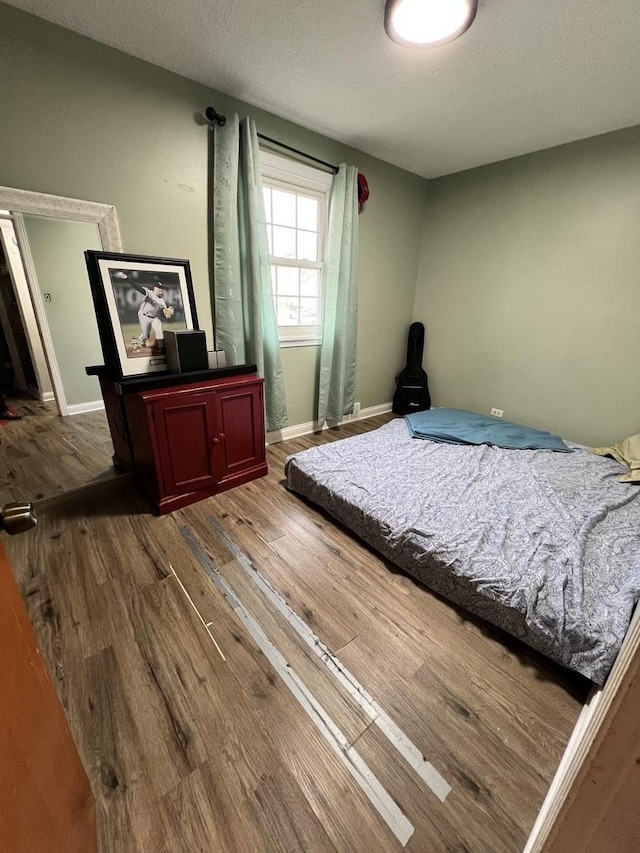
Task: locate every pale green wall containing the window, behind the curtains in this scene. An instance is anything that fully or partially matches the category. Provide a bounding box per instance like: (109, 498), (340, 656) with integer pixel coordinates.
(0, 4), (427, 424)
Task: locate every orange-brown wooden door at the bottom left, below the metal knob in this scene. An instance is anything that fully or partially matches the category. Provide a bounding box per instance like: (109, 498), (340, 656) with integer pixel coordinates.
(0, 542), (98, 853)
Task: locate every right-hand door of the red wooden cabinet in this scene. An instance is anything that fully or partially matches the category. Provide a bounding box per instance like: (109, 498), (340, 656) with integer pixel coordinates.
(214, 380), (266, 488)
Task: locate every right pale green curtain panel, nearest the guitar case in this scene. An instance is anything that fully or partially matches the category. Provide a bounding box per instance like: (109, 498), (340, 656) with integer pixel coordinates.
(317, 164), (358, 424)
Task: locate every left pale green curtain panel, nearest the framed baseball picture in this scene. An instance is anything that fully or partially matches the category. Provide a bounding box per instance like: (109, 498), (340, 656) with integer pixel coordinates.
(212, 114), (288, 430)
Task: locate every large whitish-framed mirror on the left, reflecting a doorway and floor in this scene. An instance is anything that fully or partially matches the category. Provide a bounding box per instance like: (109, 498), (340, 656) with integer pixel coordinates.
(0, 187), (122, 500)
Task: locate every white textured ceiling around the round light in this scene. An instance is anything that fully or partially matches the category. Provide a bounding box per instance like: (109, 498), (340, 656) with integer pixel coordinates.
(9, 0), (640, 178)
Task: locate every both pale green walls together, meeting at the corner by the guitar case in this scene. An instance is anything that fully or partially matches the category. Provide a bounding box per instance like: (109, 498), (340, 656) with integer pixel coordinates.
(0, 4), (640, 443)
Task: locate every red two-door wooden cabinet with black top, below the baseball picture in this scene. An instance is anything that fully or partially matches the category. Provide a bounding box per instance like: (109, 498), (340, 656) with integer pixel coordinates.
(87, 365), (267, 515)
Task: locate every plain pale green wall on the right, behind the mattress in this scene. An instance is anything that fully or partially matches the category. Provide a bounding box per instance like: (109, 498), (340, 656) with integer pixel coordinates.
(414, 127), (640, 445)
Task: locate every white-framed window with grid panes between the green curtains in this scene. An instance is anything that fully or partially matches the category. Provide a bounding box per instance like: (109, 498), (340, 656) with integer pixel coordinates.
(260, 151), (333, 346)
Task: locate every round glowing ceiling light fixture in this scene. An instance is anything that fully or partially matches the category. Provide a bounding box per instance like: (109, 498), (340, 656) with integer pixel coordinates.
(384, 0), (478, 47)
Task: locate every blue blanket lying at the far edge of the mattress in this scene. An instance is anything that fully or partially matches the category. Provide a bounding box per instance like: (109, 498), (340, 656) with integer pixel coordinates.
(404, 409), (571, 453)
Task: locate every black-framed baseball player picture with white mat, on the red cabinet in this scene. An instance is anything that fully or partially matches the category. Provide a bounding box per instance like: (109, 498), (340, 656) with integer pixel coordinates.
(84, 250), (198, 378)
